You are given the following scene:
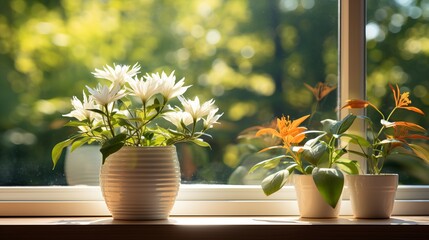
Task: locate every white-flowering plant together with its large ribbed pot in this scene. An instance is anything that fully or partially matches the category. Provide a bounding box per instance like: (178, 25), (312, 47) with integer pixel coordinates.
(52, 64), (222, 219)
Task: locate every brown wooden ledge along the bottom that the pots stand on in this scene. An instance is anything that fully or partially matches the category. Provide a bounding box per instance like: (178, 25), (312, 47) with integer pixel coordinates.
(0, 216), (429, 240)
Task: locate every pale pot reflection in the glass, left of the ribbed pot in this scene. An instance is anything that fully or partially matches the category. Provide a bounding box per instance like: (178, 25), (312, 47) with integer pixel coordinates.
(64, 145), (102, 186)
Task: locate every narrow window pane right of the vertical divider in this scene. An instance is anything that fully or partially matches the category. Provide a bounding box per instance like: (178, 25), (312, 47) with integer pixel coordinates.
(366, 0), (429, 184)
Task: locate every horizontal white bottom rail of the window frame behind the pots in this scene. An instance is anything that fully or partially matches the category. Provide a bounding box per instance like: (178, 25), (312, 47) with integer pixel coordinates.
(0, 184), (429, 217)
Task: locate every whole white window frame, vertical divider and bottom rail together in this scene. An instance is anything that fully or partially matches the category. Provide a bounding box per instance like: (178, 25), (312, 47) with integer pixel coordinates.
(0, 0), (429, 216)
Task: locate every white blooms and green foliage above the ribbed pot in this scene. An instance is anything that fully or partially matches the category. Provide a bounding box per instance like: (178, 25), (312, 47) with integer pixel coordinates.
(52, 63), (223, 168)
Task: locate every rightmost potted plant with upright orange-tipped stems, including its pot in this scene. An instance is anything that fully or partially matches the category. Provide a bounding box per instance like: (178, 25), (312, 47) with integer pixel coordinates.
(343, 85), (429, 218)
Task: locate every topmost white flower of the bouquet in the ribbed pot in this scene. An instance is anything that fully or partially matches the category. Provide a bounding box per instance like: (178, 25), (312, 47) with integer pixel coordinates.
(92, 63), (140, 86)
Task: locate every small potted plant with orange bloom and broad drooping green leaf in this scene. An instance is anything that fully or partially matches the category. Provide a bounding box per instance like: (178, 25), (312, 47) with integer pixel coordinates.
(250, 115), (359, 218)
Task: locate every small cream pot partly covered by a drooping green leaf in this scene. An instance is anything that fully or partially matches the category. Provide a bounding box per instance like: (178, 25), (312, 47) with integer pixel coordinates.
(294, 175), (341, 218)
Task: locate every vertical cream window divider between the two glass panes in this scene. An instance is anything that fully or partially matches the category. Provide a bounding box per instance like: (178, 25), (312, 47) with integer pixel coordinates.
(338, 0), (366, 173)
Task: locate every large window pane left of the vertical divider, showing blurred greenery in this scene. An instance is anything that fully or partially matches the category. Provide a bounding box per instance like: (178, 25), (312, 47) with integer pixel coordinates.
(0, 0), (338, 186)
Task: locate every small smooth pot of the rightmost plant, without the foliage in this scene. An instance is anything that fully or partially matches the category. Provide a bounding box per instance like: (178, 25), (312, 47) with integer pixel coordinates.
(346, 174), (398, 218)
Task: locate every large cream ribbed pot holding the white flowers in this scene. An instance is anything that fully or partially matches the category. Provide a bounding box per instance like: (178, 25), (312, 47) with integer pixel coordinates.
(100, 146), (180, 220)
